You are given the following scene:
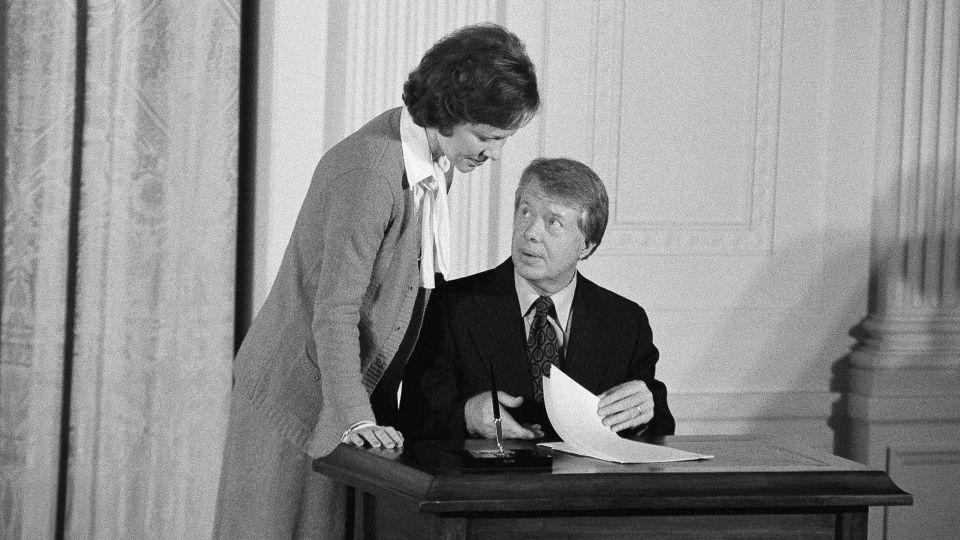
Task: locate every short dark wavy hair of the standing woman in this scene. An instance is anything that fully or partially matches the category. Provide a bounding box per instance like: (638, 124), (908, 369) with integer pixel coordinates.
(403, 23), (540, 136)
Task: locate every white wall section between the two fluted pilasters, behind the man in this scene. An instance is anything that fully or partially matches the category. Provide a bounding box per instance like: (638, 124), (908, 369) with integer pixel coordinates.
(520, 0), (873, 440)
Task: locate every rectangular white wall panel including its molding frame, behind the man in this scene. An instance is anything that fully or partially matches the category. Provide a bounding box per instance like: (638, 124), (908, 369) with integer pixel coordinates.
(612, 2), (783, 254)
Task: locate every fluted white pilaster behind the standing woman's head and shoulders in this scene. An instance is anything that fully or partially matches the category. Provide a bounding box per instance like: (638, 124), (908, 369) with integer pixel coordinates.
(327, 0), (500, 277)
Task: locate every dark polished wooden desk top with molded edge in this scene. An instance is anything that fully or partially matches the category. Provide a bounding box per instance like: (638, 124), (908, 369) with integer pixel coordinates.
(314, 435), (912, 512)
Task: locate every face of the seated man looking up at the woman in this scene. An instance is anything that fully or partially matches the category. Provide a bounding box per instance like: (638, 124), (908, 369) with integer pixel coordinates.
(511, 178), (591, 295)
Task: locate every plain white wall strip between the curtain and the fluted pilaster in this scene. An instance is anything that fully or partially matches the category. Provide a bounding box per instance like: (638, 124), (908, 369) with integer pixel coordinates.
(252, 1), (328, 313)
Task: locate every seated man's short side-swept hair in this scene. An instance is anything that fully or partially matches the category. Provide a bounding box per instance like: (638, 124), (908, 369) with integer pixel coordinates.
(513, 158), (610, 259)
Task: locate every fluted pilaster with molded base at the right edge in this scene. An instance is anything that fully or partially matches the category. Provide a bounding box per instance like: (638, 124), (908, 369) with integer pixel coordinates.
(846, 0), (960, 538)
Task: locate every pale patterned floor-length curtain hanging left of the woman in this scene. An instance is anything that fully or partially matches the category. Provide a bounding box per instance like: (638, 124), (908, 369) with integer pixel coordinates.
(0, 0), (240, 538)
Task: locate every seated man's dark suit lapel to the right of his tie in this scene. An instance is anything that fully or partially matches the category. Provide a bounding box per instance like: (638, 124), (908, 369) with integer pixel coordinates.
(561, 274), (609, 388)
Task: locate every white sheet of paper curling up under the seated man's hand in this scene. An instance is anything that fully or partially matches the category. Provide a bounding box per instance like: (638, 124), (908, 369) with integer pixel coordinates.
(543, 366), (713, 463)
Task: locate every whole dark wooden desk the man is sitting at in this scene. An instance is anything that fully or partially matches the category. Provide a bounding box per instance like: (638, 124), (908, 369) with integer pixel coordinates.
(314, 436), (912, 540)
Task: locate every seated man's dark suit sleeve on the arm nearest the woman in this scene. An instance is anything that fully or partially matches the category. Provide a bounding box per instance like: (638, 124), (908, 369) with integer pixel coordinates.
(399, 289), (464, 440)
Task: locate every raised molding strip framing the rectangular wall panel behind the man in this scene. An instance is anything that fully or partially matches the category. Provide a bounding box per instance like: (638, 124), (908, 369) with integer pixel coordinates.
(593, 0), (784, 255)
